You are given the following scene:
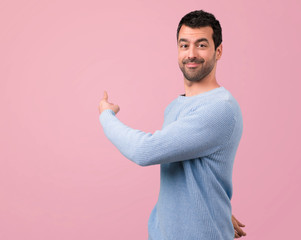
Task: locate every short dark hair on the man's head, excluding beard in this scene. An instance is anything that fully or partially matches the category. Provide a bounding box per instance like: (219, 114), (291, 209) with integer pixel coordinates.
(177, 10), (222, 50)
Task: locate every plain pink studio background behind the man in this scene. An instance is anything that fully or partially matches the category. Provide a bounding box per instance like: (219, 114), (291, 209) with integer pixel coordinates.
(0, 0), (301, 240)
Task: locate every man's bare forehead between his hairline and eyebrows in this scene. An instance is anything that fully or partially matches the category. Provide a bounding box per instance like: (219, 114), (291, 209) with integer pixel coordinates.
(179, 25), (213, 41)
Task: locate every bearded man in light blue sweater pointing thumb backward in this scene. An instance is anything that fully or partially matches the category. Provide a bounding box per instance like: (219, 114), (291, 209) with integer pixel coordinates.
(99, 10), (246, 240)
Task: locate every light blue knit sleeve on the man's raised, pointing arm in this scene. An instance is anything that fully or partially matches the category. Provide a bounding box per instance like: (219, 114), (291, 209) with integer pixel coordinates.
(99, 103), (235, 166)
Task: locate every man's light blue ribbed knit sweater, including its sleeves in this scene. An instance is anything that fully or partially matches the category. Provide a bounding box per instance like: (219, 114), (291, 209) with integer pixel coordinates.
(99, 87), (243, 240)
